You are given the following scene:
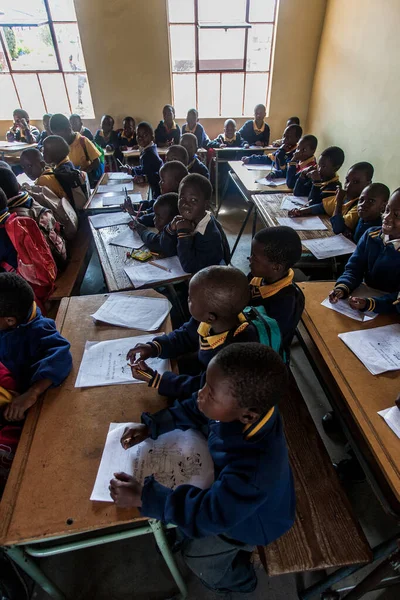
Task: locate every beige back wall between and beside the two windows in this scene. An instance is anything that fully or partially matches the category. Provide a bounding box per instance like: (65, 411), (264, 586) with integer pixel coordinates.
(0, 0), (326, 138)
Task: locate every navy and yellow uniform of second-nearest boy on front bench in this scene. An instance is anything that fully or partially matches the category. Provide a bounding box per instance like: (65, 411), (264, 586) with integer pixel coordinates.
(144, 313), (260, 400)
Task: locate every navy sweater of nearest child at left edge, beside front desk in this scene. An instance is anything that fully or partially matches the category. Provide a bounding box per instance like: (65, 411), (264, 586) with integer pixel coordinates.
(0, 302), (72, 393)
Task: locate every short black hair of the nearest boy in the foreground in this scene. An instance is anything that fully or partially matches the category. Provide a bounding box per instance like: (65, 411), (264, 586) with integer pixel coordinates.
(211, 342), (289, 415)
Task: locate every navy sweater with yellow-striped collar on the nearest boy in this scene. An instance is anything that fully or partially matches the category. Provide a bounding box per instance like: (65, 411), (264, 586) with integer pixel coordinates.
(140, 394), (295, 545)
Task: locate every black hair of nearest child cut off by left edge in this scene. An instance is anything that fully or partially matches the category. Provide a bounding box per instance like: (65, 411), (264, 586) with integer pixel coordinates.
(0, 273), (34, 323)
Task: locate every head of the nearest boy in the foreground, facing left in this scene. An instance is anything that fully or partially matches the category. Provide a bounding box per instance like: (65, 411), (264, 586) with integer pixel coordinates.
(197, 342), (289, 425)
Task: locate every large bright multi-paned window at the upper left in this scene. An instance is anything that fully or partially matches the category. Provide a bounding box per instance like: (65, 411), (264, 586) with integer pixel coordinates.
(0, 0), (94, 119)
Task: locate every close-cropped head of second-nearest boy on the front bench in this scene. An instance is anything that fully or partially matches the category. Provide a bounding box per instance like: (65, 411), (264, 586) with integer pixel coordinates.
(188, 265), (250, 331)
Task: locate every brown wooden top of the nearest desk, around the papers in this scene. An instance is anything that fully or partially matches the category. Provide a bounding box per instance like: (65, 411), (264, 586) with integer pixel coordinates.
(0, 290), (171, 545)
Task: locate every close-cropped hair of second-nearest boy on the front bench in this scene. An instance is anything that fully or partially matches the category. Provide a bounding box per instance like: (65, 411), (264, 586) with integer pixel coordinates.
(191, 265), (250, 318)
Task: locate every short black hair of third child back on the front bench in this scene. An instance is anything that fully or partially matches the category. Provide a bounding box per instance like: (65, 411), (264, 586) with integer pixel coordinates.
(254, 225), (301, 269)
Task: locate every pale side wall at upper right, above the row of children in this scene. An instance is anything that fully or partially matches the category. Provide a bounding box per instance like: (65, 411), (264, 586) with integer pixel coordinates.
(308, 0), (400, 190)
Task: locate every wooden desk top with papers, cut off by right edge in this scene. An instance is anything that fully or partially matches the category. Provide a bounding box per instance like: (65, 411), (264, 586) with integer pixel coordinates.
(298, 281), (400, 502)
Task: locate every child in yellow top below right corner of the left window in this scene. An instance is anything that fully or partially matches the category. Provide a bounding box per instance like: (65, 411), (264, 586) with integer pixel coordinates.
(50, 114), (104, 187)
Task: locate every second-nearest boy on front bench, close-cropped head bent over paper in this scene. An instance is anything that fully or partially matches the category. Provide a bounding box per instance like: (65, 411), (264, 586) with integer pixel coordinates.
(127, 266), (260, 400)
